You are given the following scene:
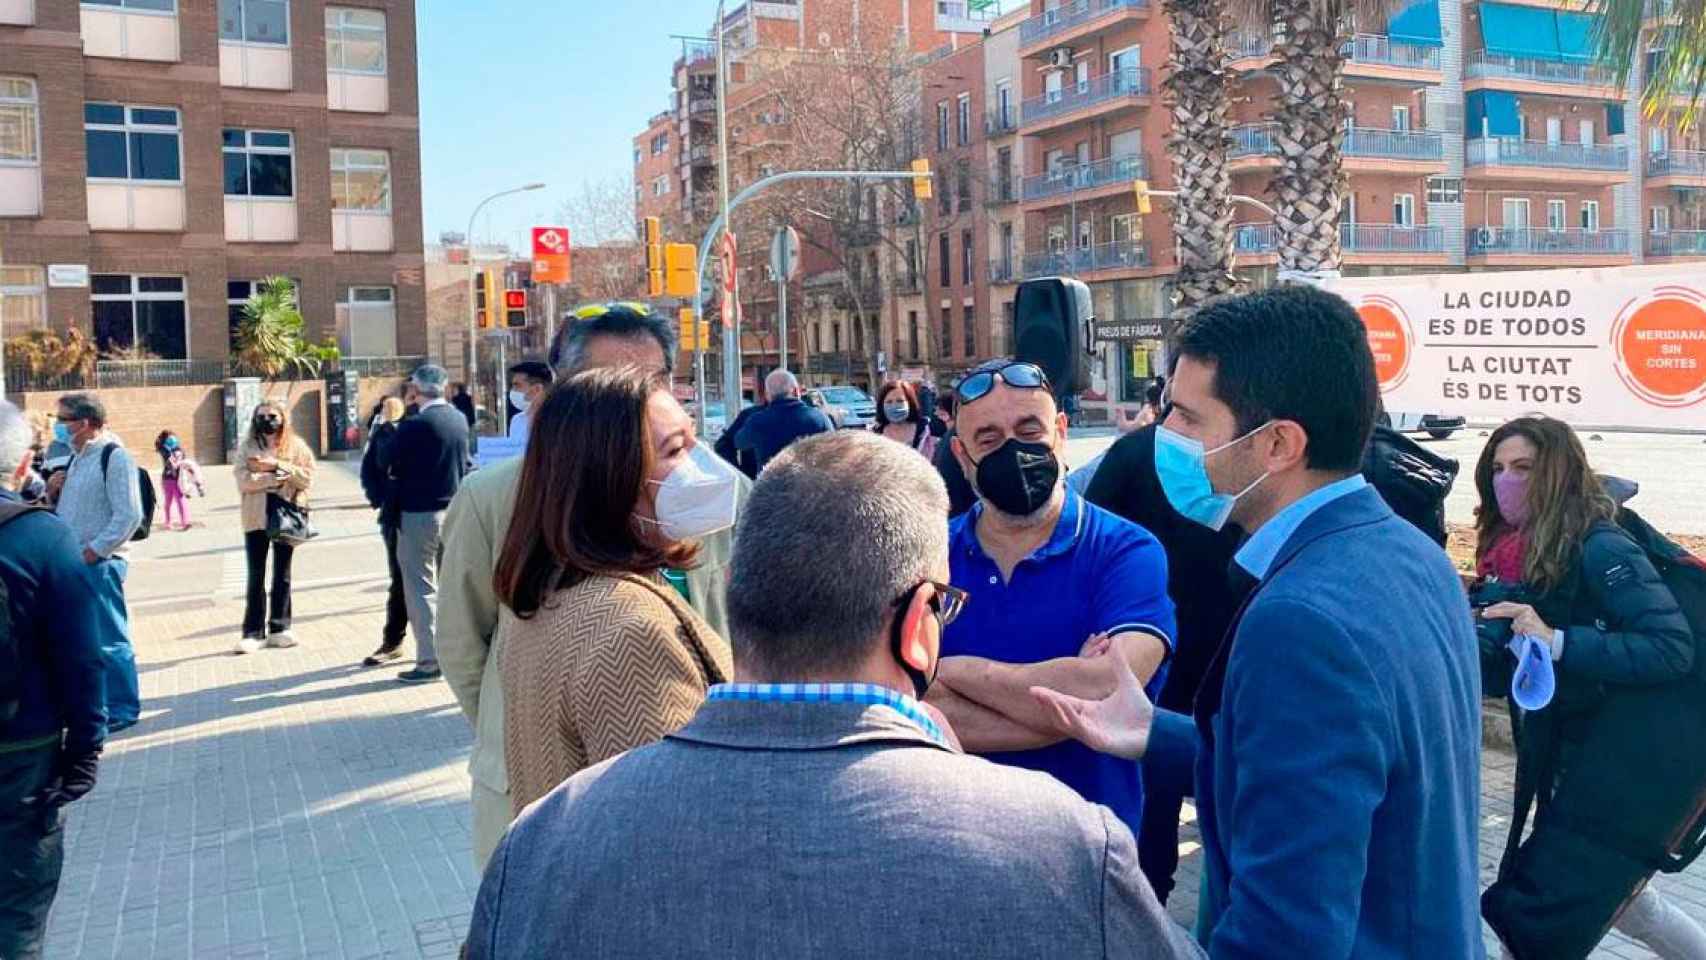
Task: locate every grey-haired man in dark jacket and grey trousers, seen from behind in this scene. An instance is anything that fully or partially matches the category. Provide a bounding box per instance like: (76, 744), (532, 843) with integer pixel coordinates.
(380, 363), (467, 684)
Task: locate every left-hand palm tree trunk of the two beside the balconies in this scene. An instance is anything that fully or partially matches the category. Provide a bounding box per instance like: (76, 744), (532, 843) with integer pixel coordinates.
(1163, 0), (1239, 315)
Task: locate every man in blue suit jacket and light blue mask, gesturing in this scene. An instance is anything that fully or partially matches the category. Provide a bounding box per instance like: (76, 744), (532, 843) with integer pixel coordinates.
(1036, 288), (1483, 960)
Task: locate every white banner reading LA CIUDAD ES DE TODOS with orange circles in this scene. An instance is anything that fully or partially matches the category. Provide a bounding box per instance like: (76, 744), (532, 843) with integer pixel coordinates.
(1327, 266), (1706, 430)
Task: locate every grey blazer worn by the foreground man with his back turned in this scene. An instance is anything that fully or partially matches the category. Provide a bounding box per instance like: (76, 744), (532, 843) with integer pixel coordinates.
(467, 701), (1203, 960)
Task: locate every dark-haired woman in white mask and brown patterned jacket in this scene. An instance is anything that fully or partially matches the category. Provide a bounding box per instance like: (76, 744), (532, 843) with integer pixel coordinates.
(493, 367), (739, 813)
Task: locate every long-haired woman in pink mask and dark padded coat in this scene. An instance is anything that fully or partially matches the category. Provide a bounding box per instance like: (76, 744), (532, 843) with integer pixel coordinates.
(1474, 418), (1706, 960)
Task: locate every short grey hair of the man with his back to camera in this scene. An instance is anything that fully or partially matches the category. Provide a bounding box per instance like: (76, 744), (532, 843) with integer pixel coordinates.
(728, 430), (949, 680)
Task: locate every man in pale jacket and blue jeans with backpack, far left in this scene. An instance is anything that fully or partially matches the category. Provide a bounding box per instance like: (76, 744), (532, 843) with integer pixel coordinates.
(53, 394), (142, 733)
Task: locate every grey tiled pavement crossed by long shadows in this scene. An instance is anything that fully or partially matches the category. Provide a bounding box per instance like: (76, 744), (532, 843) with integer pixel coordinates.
(48, 460), (1706, 960)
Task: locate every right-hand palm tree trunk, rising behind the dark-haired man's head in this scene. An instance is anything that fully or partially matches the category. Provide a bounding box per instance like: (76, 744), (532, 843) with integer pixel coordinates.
(1271, 0), (1349, 278)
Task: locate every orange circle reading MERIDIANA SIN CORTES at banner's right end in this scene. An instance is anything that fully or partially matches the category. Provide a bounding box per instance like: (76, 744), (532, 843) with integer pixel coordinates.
(1610, 286), (1706, 408)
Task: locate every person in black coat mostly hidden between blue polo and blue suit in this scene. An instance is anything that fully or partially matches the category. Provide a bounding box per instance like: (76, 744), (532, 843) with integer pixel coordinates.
(1085, 425), (1252, 904)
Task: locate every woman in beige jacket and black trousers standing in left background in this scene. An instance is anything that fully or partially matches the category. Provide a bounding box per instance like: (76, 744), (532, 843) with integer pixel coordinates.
(237, 401), (314, 653)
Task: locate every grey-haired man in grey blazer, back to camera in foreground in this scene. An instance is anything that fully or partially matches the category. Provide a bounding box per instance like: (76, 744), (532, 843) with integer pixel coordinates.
(467, 431), (1201, 960)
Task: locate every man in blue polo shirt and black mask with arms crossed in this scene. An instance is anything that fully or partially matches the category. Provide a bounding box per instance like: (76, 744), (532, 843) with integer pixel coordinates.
(926, 360), (1174, 834)
